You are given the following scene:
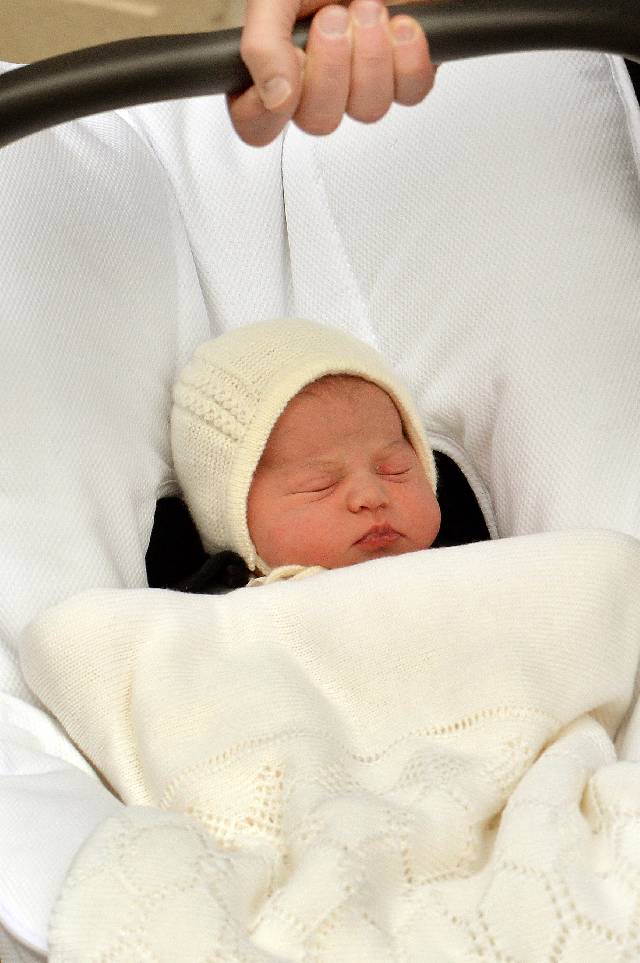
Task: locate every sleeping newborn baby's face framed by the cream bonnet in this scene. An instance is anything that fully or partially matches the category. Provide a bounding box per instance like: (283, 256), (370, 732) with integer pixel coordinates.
(248, 376), (440, 568)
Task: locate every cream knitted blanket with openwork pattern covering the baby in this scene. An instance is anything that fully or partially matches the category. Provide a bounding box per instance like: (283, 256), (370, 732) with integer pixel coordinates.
(17, 532), (640, 963)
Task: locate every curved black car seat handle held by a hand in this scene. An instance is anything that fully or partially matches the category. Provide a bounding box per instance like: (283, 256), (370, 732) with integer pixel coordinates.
(0, 0), (640, 147)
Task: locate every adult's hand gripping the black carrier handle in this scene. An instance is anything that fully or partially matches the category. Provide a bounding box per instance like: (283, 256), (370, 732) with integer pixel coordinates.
(227, 0), (437, 147)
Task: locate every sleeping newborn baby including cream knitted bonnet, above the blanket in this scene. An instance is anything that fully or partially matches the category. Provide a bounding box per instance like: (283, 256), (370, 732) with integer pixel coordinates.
(171, 318), (440, 581)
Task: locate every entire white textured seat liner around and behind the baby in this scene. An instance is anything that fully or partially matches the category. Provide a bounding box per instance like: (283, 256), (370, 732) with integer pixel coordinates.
(0, 53), (640, 948)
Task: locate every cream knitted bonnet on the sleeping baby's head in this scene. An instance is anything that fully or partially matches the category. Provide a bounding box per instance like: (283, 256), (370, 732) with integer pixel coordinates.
(171, 318), (436, 575)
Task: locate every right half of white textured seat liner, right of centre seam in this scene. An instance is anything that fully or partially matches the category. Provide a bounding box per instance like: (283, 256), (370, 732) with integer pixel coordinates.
(283, 52), (640, 535)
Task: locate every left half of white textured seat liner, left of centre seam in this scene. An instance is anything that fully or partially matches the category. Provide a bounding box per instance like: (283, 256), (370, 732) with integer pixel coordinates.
(0, 65), (288, 963)
